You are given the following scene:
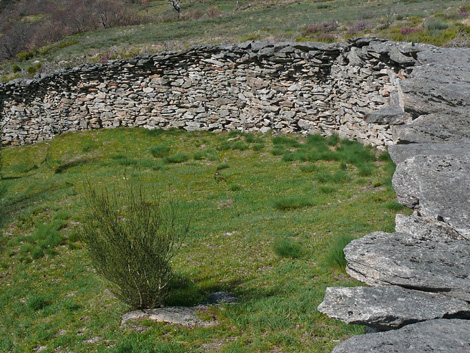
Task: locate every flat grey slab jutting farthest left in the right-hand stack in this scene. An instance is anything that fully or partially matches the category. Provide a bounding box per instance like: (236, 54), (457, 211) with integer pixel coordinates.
(318, 286), (470, 330)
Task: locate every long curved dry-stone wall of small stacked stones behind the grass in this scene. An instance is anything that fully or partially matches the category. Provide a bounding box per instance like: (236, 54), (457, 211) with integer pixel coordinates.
(0, 39), (417, 146)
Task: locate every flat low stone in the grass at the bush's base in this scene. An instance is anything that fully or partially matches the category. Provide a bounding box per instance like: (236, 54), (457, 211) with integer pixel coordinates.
(121, 306), (218, 327)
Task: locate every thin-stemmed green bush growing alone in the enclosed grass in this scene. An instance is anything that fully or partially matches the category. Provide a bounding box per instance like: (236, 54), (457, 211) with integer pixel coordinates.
(81, 183), (189, 308)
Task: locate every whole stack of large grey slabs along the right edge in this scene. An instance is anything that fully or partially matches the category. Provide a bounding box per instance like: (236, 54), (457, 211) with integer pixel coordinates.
(318, 48), (470, 353)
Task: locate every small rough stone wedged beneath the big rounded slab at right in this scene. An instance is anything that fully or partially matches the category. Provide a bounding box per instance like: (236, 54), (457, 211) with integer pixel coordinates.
(395, 214), (465, 240)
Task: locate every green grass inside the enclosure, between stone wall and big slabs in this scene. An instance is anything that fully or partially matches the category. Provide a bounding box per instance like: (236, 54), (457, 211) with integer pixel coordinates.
(0, 129), (409, 353)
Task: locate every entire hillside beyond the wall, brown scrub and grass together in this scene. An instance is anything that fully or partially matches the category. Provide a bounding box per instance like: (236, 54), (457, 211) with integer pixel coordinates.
(0, 0), (470, 81)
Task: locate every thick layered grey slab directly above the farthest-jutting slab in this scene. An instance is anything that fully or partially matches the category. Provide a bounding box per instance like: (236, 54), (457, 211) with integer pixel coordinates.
(344, 232), (470, 301)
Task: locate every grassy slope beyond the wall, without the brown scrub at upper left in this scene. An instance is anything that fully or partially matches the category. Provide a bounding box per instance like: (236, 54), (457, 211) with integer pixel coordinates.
(0, 0), (470, 81)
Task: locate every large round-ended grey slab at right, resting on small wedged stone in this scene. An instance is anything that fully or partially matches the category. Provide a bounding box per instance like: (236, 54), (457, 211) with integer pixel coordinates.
(392, 152), (470, 239)
